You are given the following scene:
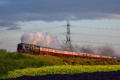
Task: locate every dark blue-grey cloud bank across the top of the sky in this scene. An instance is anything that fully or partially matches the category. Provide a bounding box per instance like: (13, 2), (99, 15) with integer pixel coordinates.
(0, 0), (120, 27)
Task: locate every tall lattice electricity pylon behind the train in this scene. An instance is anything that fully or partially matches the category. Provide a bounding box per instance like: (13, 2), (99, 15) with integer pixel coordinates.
(66, 20), (72, 51)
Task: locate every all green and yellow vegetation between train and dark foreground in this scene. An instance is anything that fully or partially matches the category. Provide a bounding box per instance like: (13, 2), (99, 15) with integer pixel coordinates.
(0, 50), (120, 78)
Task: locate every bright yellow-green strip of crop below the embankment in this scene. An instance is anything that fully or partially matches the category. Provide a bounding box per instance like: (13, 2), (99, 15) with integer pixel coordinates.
(3, 65), (120, 78)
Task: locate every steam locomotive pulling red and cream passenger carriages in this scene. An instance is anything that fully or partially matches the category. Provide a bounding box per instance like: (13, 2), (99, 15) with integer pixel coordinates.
(17, 43), (113, 59)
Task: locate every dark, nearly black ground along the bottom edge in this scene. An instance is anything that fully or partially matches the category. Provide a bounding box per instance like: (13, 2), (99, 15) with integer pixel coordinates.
(1, 71), (120, 80)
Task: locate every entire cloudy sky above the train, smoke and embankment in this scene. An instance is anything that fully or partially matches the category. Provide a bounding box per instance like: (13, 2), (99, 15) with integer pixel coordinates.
(0, 0), (120, 54)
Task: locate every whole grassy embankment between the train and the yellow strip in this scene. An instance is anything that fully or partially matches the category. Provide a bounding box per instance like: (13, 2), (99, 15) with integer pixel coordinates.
(0, 50), (120, 79)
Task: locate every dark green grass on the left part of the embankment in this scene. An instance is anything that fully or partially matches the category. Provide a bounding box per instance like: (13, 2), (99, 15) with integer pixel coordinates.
(0, 52), (54, 74)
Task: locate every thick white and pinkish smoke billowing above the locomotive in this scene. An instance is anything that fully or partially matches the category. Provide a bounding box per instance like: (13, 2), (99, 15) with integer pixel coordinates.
(21, 32), (61, 49)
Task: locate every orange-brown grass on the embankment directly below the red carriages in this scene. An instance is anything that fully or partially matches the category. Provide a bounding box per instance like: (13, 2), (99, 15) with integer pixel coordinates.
(27, 54), (120, 65)
